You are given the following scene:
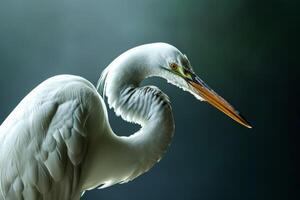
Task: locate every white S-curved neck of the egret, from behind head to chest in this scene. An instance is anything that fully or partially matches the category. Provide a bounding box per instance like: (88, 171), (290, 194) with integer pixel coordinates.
(103, 47), (174, 180)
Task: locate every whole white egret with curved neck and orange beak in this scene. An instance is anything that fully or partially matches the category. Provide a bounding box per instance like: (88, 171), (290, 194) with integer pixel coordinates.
(0, 43), (250, 200)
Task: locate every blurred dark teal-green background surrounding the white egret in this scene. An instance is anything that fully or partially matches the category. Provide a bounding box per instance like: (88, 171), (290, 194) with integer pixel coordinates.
(0, 0), (300, 200)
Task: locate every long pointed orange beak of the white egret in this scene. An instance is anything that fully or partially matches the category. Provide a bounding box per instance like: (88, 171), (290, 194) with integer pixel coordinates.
(187, 74), (252, 128)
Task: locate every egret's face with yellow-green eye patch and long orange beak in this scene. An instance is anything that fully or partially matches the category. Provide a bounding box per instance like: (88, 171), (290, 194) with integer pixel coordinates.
(160, 43), (252, 128)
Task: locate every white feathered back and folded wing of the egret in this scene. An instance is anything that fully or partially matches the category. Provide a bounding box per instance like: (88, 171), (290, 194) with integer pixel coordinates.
(0, 75), (107, 200)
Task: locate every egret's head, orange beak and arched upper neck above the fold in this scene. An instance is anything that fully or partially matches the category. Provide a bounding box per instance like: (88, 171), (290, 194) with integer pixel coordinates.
(97, 43), (251, 128)
